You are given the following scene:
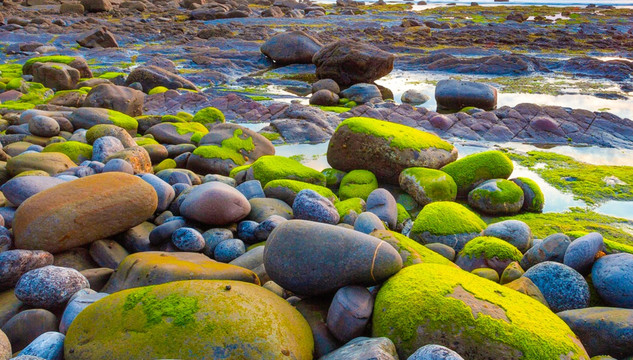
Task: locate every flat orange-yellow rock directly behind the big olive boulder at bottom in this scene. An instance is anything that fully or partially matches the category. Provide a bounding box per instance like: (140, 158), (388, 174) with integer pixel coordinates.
(102, 251), (259, 293)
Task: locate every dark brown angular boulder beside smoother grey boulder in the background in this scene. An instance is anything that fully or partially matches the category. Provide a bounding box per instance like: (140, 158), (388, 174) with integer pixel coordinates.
(312, 39), (395, 86)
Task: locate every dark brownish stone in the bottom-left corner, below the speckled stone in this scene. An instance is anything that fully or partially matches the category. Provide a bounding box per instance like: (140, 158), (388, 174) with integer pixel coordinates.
(2, 309), (59, 352)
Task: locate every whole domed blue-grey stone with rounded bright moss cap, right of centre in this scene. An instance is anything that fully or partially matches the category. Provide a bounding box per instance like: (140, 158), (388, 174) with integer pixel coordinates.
(409, 201), (486, 251)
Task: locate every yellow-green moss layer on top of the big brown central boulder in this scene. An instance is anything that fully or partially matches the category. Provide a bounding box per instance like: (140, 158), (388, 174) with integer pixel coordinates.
(337, 117), (453, 151)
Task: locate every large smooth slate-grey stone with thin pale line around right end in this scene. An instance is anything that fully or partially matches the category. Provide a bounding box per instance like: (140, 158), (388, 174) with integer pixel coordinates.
(264, 220), (402, 295)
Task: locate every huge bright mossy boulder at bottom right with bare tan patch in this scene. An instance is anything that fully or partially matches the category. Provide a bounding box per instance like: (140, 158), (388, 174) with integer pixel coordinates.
(372, 263), (589, 360)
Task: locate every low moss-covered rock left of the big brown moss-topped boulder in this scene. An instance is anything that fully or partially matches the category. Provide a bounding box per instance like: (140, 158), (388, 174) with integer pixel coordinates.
(247, 155), (325, 186)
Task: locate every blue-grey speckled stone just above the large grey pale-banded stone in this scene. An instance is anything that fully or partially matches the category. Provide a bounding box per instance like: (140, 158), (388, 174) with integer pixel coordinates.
(292, 189), (340, 225)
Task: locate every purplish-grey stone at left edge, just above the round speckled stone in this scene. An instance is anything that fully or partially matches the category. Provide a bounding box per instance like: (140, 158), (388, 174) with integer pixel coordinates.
(0, 250), (53, 290)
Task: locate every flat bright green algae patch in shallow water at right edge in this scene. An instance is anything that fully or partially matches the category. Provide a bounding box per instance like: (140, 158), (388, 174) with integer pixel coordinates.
(508, 151), (633, 205)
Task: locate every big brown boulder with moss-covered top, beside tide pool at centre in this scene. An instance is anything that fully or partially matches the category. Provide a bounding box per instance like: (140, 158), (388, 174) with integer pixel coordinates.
(327, 117), (457, 184)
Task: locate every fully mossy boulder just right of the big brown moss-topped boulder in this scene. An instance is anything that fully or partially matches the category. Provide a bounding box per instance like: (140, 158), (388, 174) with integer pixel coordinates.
(441, 150), (514, 197)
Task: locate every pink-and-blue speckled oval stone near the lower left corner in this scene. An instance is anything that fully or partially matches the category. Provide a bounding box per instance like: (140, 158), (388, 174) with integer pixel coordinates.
(15, 265), (90, 309)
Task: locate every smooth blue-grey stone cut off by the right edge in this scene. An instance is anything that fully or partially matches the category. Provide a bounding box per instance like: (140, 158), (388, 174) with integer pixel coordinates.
(591, 253), (633, 309)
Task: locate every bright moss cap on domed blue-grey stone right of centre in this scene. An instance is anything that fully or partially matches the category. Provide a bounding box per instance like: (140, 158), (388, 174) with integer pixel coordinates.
(411, 201), (486, 235)
